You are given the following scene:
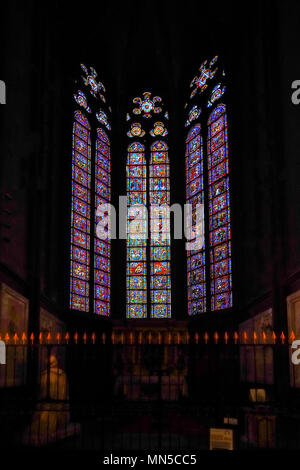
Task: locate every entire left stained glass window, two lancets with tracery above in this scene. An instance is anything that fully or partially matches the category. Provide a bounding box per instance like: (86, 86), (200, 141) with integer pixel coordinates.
(70, 64), (110, 316)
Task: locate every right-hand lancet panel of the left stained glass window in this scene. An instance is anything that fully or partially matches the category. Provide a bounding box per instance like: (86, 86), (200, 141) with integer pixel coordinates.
(94, 129), (110, 316)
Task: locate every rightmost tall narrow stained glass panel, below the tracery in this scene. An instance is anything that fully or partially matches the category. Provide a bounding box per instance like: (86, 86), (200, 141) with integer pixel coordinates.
(207, 104), (232, 310)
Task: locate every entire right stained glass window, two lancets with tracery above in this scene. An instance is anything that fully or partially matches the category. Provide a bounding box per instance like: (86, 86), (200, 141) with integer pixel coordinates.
(185, 56), (232, 315)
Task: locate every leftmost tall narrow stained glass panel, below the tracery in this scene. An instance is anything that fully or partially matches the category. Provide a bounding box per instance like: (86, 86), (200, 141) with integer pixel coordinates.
(70, 111), (91, 312)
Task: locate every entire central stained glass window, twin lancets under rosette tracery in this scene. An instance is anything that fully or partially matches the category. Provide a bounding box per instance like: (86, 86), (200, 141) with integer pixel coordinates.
(126, 92), (171, 318)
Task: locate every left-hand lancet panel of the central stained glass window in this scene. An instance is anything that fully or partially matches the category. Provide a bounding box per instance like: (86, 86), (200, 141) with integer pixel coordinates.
(126, 142), (148, 318)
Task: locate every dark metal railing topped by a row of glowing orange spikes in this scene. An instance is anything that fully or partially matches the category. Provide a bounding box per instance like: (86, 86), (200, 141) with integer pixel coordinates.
(0, 331), (300, 450)
